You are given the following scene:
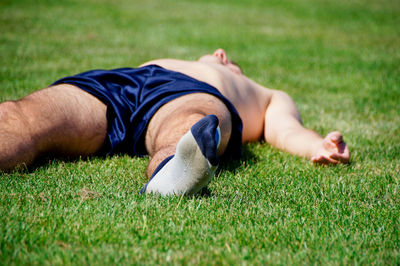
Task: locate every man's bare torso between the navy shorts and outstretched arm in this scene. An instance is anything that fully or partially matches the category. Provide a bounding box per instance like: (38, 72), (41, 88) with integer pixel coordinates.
(142, 59), (272, 142)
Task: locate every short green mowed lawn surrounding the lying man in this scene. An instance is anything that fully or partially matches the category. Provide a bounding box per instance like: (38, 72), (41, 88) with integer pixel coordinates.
(0, 0), (400, 265)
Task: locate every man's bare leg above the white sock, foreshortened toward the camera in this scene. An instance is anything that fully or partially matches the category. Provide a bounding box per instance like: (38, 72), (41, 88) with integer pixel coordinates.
(146, 93), (232, 181)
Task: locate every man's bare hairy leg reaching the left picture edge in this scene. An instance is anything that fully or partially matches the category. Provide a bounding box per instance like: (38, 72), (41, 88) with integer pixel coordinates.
(0, 84), (107, 170)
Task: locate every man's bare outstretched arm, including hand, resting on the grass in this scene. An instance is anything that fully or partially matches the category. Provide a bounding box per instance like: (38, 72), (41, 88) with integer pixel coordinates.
(264, 91), (350, 164)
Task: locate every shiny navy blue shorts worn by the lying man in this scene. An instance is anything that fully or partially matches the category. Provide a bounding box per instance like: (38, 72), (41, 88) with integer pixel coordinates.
(52, 65), (242, 158)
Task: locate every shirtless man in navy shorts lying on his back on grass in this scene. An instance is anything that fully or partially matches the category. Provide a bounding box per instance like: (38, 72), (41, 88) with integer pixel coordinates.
(0, 49), (350, 195)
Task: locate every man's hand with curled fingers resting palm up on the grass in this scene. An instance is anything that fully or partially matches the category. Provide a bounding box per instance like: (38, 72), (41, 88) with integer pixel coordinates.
(311, 131), (350, 164)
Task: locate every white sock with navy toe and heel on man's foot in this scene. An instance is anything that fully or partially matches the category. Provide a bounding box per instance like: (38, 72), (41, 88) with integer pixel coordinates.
(140, 115), (221, 195)
